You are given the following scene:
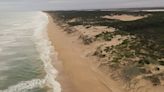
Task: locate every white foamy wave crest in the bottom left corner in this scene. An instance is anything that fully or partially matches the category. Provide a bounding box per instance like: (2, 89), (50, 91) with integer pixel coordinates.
(0, 79), (45, 92)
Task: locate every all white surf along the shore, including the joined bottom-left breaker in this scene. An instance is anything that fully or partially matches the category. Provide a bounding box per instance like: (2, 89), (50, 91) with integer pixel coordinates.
(0, 12), (61, 92)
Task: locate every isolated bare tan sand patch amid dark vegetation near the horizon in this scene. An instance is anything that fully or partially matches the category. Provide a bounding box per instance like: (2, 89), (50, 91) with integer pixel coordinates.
(102, 14), (148, 21)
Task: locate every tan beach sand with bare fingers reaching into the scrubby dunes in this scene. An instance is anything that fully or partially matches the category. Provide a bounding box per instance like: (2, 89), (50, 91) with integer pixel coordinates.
(48, 13), (164, 92)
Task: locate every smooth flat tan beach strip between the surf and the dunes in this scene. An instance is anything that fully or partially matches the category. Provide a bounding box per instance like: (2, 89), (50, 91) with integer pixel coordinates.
(48, 17), (112, 92)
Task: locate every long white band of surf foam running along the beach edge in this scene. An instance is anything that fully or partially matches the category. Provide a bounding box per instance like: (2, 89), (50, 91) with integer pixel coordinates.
(34, 12), (61, 92)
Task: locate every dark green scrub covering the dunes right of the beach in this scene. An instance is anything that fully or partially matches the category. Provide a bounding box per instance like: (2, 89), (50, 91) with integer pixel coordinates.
(49, 11), (164, 86)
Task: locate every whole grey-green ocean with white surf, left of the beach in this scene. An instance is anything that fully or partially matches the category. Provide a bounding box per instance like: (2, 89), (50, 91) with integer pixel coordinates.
(0, 12), (61, 92)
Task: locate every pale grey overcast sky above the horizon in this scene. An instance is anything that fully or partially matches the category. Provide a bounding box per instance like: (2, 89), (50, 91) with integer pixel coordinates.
(0, 0), (164, 10)
